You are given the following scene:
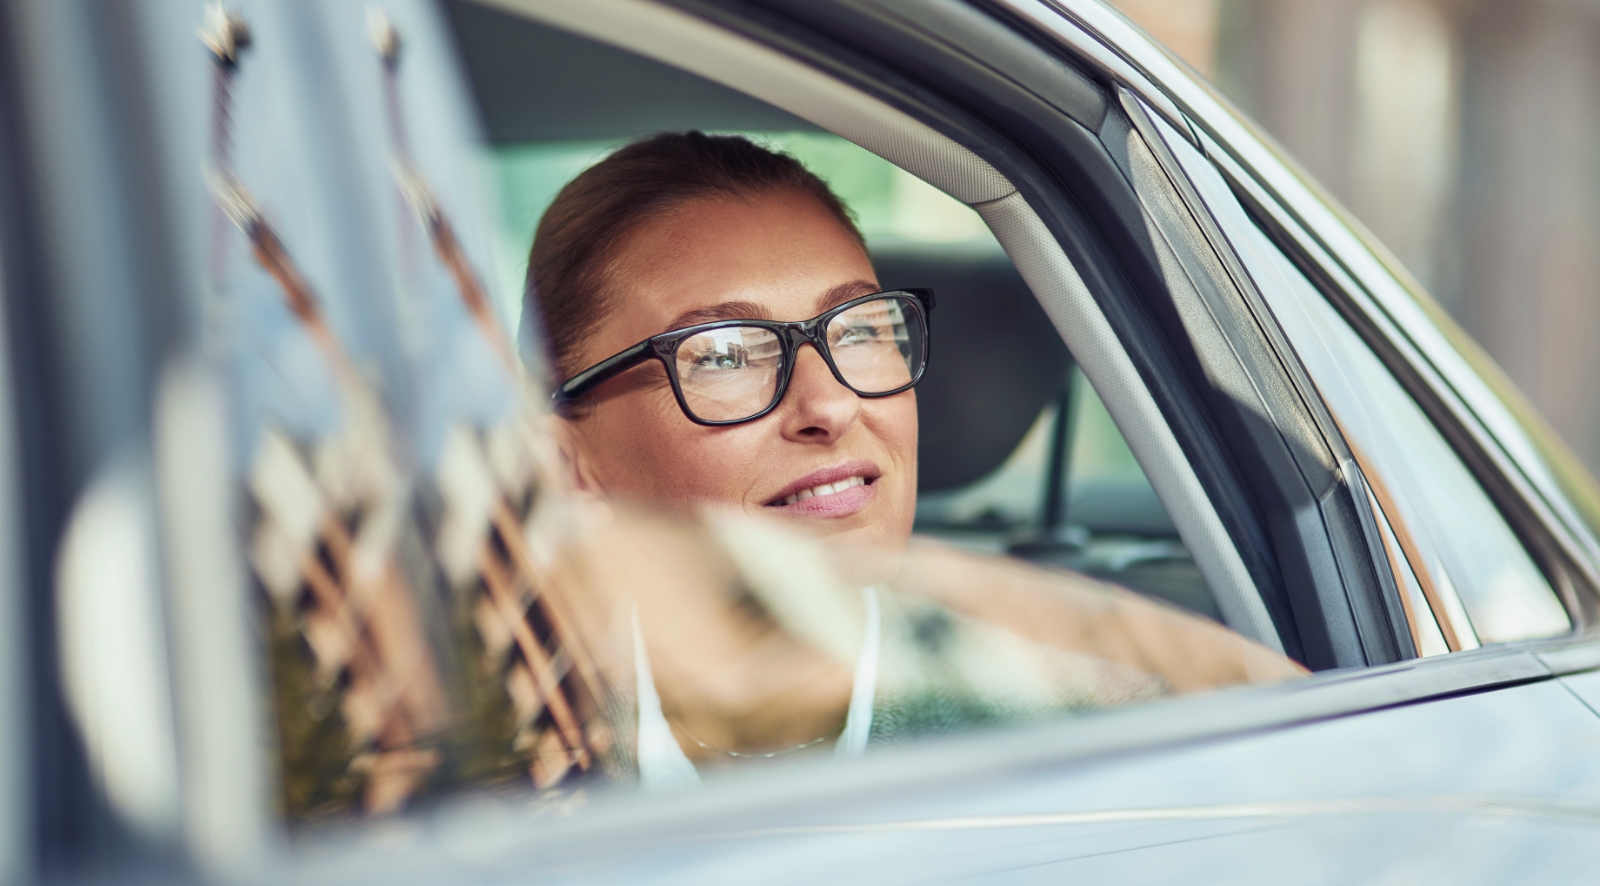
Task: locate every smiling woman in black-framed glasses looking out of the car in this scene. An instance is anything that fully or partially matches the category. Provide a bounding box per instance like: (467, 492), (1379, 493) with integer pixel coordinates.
(528, 133), (1299, 787)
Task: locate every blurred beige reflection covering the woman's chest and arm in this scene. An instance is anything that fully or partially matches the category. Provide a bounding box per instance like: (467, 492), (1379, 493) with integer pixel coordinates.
(534, 502), (1304, 788)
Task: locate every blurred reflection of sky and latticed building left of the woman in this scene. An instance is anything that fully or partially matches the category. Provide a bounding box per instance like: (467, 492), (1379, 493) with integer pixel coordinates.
(203, 8), (613, 830)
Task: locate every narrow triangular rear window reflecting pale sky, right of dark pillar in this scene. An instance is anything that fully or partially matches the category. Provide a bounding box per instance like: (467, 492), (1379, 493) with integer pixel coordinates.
(1166, 113), (1571, 649)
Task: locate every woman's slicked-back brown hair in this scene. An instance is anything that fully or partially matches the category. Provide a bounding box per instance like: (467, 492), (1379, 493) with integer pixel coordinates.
(523, 133), (866, 379)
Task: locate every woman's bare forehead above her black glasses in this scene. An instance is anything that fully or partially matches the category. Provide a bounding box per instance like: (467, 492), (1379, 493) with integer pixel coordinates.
(602, 189), (875, 337)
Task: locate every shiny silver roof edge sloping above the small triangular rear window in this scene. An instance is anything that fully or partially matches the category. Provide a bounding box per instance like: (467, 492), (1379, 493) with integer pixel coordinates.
(1000, 0), (1600, 636)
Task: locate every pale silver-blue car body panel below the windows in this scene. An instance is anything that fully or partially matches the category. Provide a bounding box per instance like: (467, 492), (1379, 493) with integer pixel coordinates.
(294, 671), (1600, 883)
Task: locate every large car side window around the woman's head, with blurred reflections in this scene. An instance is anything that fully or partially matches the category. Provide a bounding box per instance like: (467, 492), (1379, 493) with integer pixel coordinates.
(124, 2), (1306, 835)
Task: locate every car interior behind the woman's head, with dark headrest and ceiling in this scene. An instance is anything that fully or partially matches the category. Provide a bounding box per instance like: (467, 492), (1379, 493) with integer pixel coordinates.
(446, 3), (1222, 621)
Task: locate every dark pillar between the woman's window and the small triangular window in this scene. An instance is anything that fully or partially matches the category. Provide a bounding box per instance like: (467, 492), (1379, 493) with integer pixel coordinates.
(674, 0), (1433, 668)
